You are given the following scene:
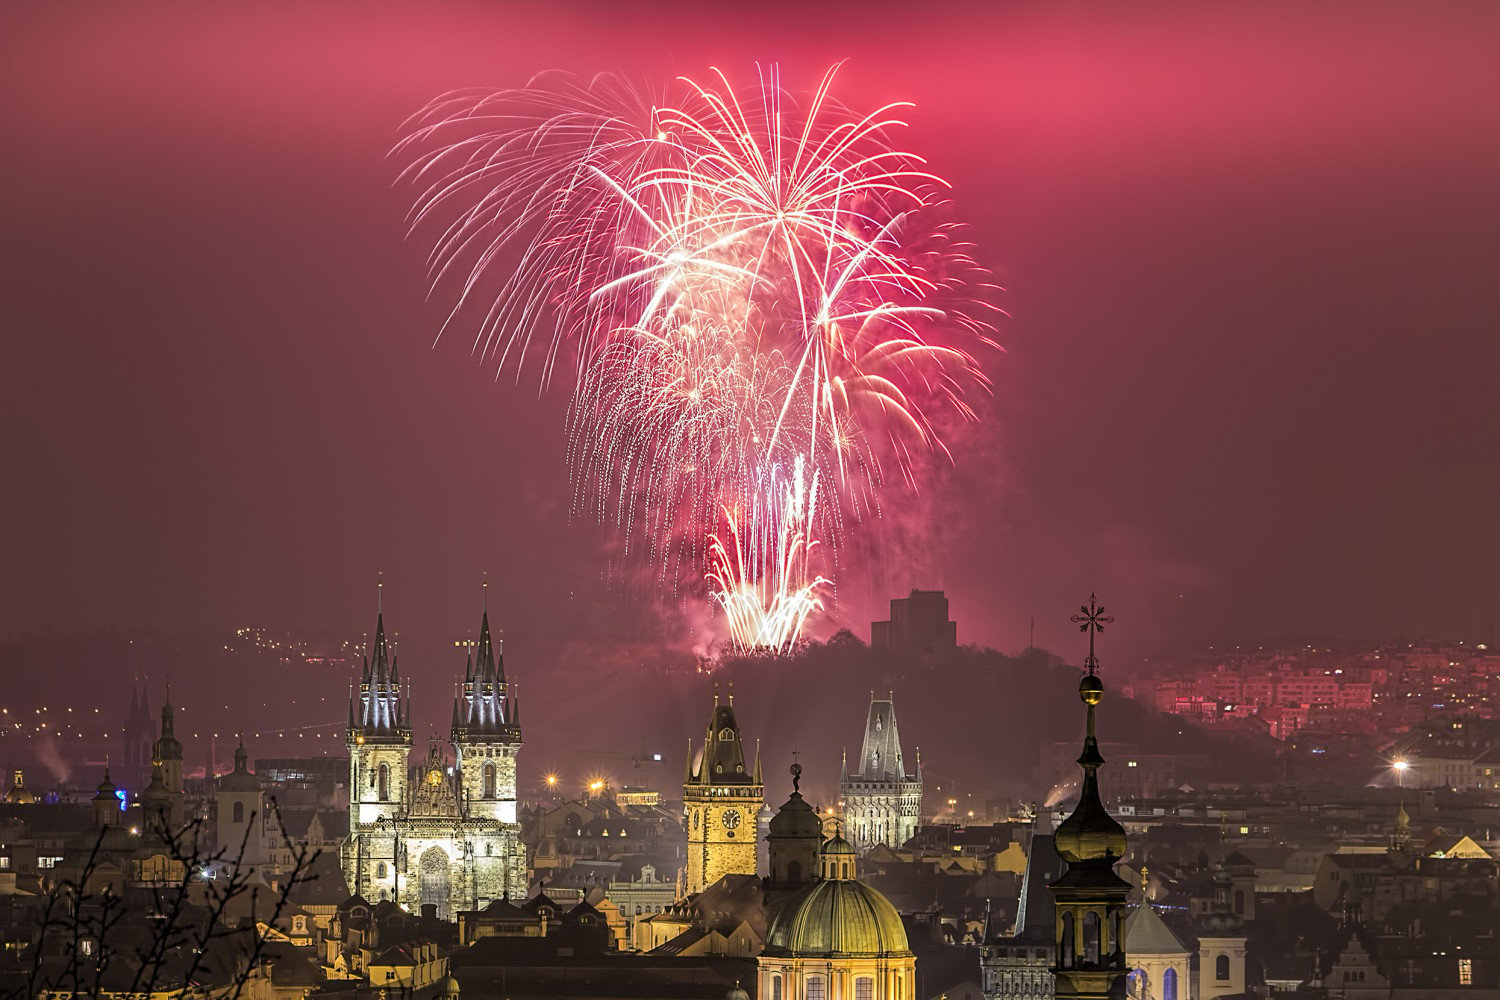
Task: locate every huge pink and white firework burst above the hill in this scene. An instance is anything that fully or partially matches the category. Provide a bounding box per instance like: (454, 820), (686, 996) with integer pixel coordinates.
(398, 69), (993, 648)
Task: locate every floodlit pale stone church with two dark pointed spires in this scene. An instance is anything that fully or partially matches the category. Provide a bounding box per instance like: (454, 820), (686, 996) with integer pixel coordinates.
(341, 612), (527, 919)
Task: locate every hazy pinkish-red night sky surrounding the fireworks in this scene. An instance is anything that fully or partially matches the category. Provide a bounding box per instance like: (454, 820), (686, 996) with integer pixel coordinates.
(0, 3), (1500, 676)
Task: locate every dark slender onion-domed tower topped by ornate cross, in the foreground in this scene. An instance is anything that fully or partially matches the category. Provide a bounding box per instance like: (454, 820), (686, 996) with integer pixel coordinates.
(1050, 594), (1130, 1000)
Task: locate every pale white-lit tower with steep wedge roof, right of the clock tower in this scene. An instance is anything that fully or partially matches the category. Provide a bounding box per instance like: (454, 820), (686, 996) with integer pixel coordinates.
(839, 691), (923, 852)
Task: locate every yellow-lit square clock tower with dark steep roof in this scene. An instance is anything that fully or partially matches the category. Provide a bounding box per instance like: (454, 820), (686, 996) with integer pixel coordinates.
(683, 694), (765, 895)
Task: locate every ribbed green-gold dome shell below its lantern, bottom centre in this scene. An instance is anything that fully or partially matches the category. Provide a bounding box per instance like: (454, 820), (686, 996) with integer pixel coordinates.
(765, 879), (911, 958)
